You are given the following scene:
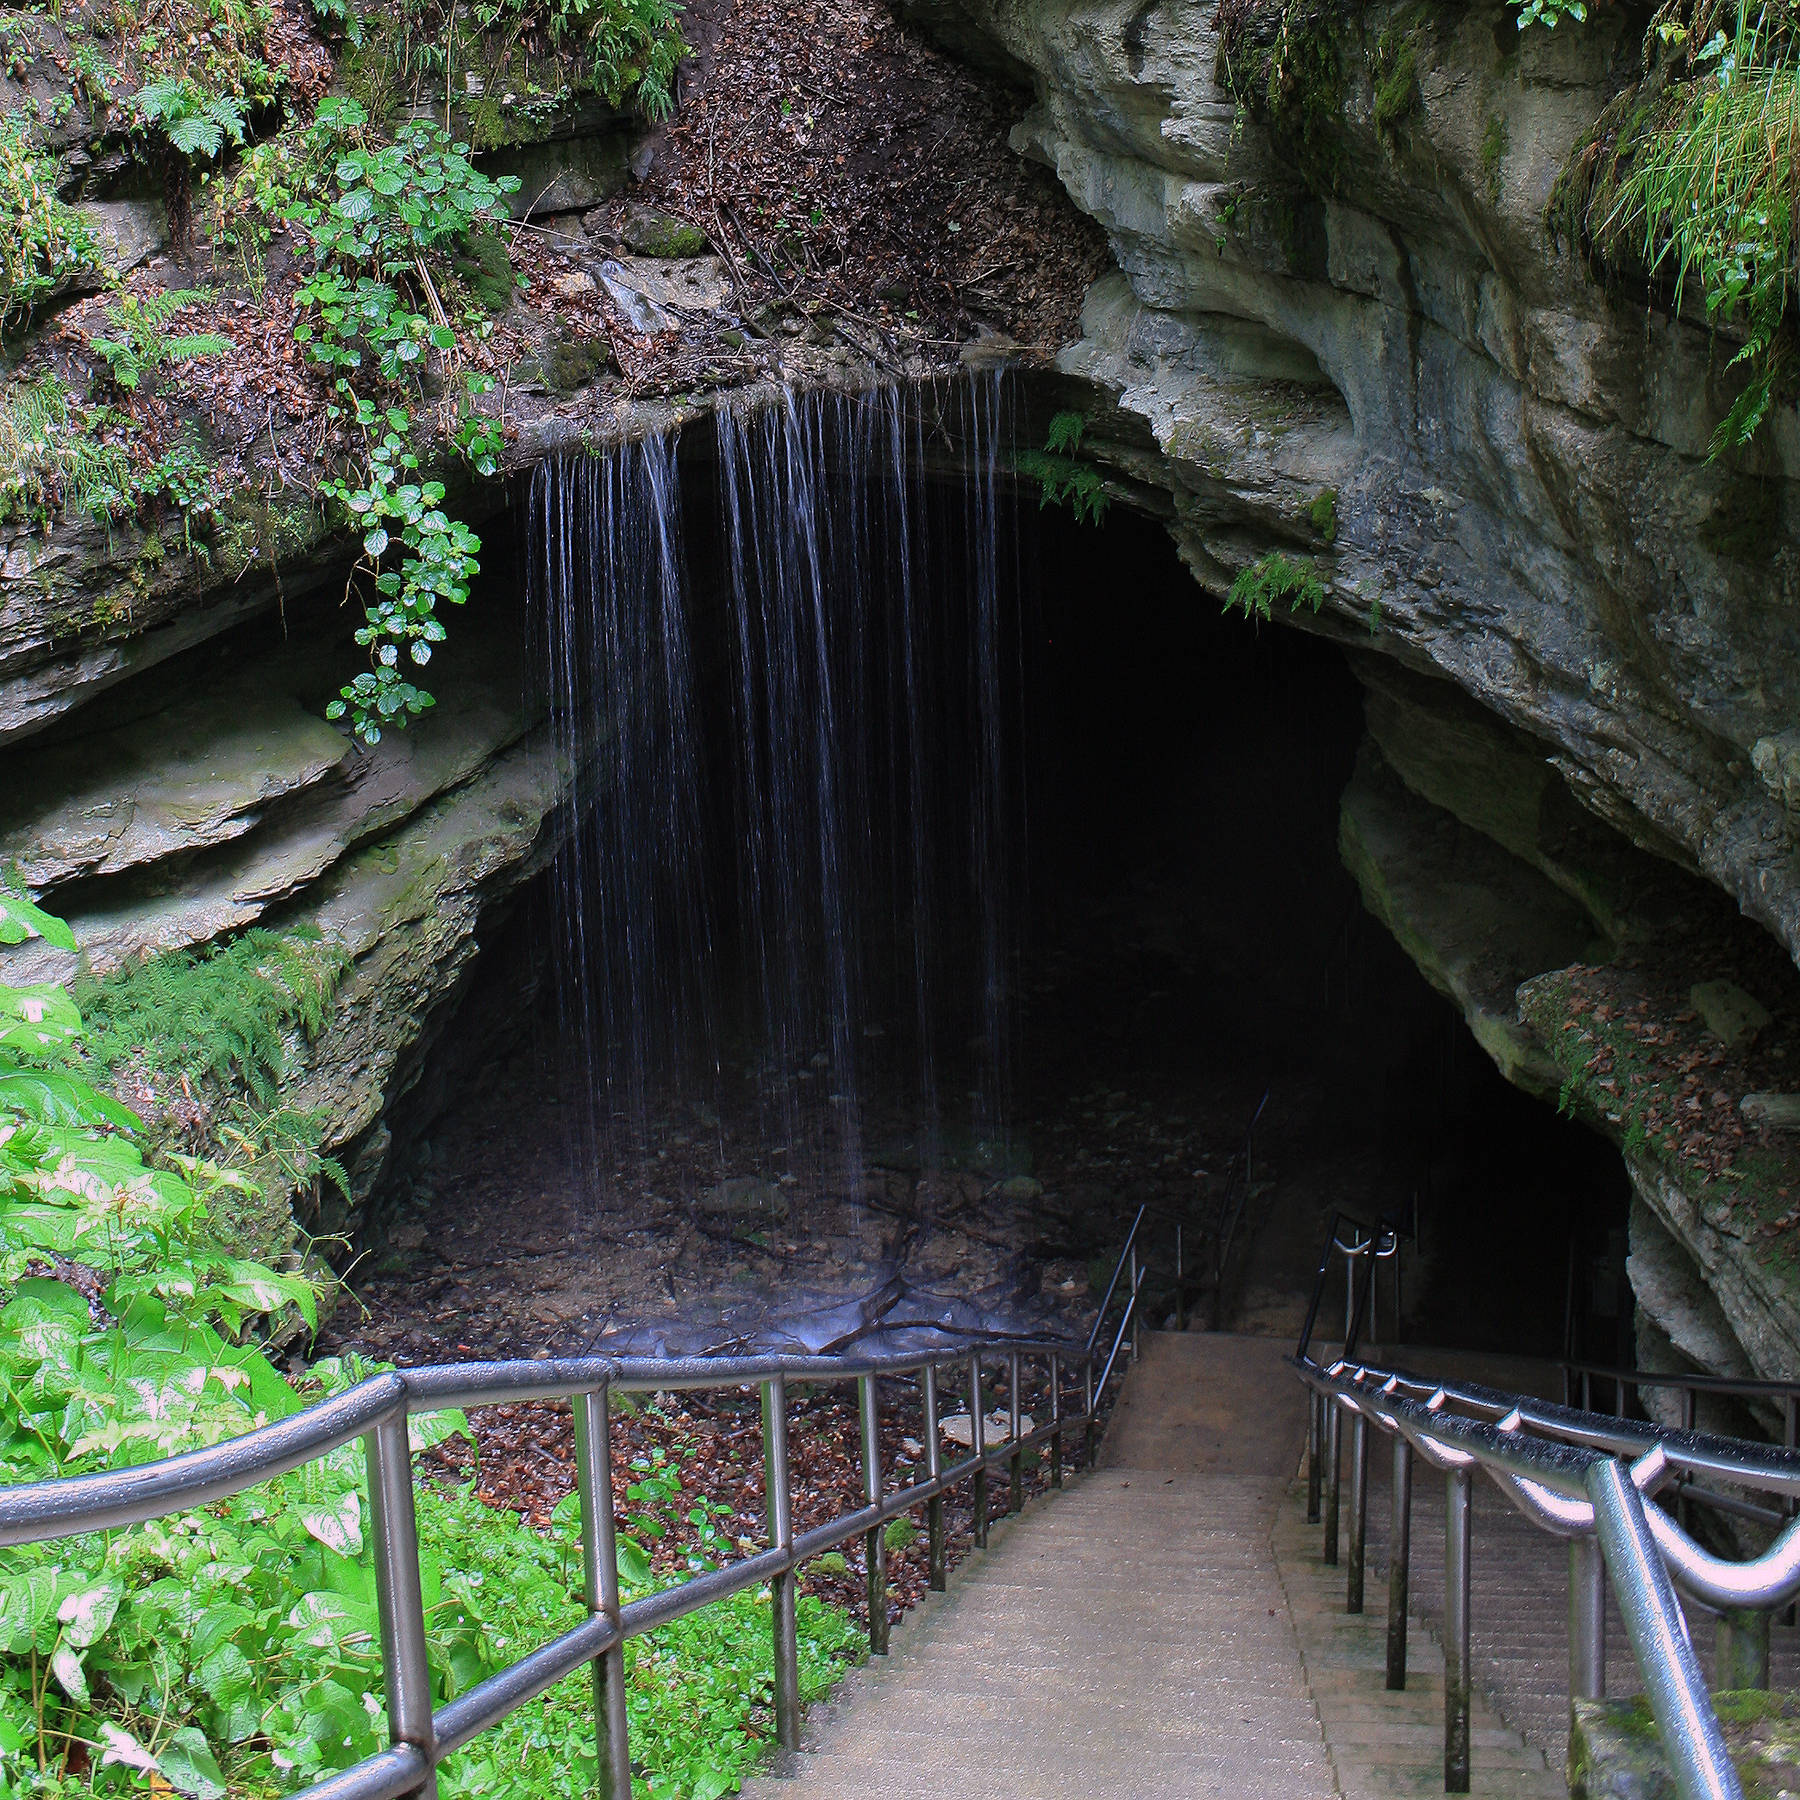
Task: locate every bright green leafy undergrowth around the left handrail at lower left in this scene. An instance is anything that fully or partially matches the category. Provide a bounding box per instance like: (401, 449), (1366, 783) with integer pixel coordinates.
(0, 887), (860, 1800)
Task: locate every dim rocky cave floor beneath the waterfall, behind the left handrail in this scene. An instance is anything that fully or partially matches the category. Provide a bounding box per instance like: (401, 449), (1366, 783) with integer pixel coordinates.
(322, 874), (1291, 1363)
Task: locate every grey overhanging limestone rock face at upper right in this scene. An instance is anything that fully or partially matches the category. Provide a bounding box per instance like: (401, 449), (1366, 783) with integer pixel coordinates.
(907, 0), (1800, 979)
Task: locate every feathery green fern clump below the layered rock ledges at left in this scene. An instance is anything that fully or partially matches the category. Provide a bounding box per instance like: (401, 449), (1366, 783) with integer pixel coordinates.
(77, 929), (349, 1105)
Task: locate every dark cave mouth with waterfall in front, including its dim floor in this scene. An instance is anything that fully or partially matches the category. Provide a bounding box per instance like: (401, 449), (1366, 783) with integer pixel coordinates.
(338, 389), (1625, 1354)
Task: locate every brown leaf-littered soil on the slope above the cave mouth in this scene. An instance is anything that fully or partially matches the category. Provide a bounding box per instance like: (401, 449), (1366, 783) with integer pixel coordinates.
(16, 0), (1109, 522)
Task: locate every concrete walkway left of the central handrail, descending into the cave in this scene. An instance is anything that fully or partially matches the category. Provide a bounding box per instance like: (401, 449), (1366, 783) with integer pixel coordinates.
(745, 1334), (1339, 1800)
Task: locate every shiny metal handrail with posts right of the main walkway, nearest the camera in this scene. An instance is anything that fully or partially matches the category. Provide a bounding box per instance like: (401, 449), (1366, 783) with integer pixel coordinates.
(1292, 1355), (1800, 1800)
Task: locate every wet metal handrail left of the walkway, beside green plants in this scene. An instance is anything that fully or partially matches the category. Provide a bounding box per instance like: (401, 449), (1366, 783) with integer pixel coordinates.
(0, 1206), (1209, 1800)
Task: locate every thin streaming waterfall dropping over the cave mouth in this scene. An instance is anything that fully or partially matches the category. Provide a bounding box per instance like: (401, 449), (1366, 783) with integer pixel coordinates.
(527, 376), (1030, 1184)
